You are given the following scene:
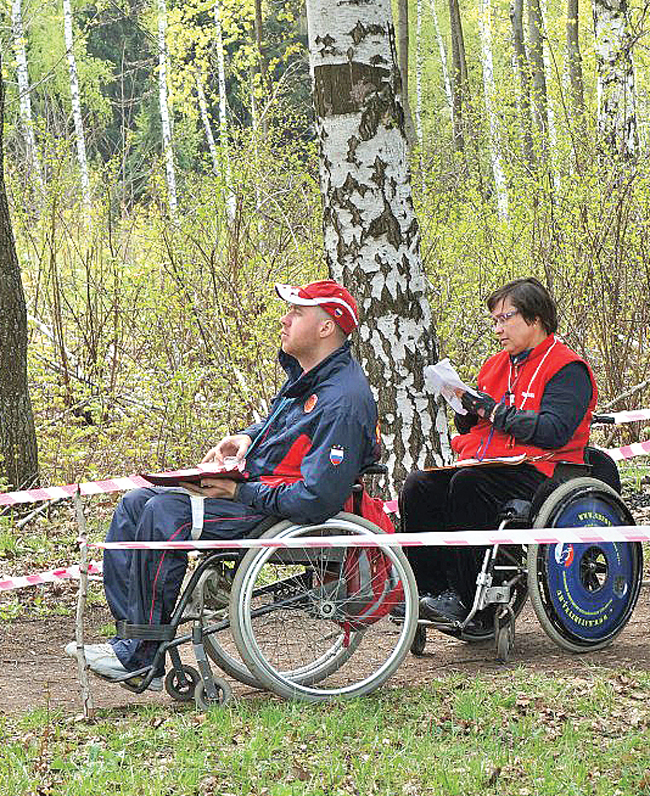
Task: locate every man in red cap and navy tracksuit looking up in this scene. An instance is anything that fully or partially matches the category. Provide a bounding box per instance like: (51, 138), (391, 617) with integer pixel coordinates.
(66, 280), (379, 690)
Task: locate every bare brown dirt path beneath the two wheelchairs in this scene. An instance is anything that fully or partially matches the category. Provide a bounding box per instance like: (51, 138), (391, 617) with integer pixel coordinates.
(0, 586), (650, 715)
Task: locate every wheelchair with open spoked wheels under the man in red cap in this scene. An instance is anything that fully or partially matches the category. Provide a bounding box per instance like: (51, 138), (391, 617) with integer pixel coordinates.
(110, 467), (418, 709)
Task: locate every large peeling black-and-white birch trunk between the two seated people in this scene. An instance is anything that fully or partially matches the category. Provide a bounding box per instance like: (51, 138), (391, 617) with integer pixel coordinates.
(307, 0), (447, 486)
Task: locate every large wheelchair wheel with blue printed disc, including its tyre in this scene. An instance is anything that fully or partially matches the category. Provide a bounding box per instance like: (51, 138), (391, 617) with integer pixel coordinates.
(528, 478), (643, 652)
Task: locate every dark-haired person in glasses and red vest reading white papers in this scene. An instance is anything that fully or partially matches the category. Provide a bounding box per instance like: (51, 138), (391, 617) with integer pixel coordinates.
(400, 278), (597, 622)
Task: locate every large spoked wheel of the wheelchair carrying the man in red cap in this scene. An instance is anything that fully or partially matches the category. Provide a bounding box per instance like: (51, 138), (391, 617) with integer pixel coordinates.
(230, 513), (418, 702)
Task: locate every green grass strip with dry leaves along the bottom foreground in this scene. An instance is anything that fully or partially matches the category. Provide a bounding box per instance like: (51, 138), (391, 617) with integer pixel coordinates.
(0, 670), (650, 796)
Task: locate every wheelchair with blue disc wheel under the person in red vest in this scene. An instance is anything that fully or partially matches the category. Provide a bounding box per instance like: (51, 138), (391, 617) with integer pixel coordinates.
(411, 447), (643, 662)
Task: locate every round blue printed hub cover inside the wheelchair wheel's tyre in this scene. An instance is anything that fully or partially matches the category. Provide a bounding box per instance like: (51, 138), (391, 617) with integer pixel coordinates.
(545, 494), (636, 640)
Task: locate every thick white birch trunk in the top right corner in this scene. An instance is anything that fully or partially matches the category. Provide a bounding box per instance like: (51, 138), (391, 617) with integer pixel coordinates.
(593, 0), (638, 159)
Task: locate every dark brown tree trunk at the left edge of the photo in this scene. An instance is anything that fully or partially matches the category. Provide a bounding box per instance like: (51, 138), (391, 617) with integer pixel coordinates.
(0, 52), (38, 489)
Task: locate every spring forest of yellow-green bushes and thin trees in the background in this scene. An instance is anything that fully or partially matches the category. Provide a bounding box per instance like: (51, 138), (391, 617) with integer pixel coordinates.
(0, 0), (650, 494)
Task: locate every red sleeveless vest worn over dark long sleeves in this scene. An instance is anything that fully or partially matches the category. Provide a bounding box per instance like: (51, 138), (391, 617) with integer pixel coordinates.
(451, 334), (598, 476)
